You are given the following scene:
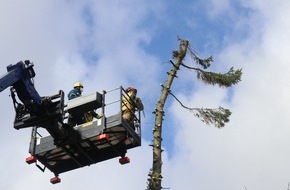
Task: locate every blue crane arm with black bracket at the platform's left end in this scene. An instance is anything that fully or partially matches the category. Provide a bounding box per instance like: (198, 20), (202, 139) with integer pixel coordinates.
(0, 60), (64, 135)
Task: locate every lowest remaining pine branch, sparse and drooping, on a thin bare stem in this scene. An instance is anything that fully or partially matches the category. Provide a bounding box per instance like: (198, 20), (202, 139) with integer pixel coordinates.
(169, 92), (231, 128)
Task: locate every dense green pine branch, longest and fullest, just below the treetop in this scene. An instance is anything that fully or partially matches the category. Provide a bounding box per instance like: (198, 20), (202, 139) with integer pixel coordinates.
(181, 63), (242, 88)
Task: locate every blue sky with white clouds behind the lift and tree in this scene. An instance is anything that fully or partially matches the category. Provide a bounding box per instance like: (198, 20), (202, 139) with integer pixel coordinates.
(0, 0), (290, 190)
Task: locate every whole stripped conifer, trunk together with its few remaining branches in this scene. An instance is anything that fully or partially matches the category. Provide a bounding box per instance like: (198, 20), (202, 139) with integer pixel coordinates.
(147, 38), (242, 190)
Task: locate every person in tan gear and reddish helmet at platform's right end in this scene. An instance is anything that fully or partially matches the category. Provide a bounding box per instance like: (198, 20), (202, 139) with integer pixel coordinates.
(122, 87), (144, 127)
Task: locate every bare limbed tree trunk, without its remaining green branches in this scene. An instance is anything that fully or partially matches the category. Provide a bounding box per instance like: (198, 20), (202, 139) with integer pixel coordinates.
(148, 40), (188, 190)
